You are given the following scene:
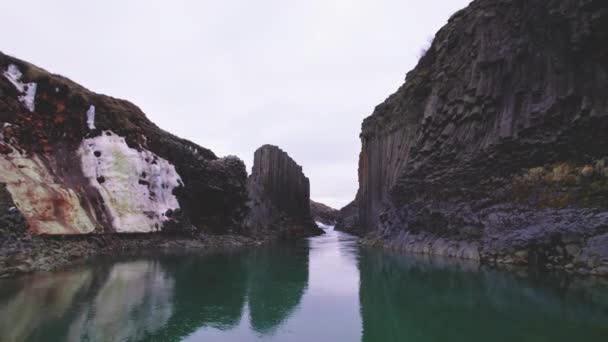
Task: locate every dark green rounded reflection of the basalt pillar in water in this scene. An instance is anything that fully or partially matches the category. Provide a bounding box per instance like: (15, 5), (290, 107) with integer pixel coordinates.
(247, 241), (309, 333)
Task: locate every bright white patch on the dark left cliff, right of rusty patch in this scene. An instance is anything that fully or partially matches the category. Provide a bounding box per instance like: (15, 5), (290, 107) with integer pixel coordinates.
(78, 131), (182, 232)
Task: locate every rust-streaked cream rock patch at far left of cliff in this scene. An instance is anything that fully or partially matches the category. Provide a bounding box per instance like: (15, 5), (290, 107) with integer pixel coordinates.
(0, 144), (95, 234)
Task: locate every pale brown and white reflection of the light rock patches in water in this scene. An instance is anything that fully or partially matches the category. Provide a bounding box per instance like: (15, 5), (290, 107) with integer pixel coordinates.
(0, 261), (174, 342)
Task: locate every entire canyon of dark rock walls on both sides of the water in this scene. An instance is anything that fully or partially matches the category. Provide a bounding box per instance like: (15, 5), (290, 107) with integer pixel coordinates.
(0, 0), (608, 275)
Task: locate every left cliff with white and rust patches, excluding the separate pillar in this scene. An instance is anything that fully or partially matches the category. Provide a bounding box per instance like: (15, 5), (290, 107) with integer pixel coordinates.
(0, 53), (247, 235)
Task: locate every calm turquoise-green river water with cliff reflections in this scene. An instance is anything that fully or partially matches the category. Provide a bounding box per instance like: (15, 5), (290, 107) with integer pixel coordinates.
(0, 231), (608, 342)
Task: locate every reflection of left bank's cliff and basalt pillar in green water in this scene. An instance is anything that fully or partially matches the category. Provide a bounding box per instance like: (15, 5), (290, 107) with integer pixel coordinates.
(0, 246), (308, 341)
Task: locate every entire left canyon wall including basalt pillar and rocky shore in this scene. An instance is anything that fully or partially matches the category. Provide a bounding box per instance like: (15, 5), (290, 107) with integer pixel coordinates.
(0, 53), (323, 275)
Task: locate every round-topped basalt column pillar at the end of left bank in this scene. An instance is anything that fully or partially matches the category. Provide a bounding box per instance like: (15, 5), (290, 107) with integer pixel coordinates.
(247, 145), (322, 235)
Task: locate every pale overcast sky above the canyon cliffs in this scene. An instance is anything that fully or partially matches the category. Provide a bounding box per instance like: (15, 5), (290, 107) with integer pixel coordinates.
(0, 0), (470, 208)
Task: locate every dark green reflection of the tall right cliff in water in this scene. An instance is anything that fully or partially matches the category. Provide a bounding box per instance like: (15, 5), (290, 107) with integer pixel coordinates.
(359, 250), (608, 342)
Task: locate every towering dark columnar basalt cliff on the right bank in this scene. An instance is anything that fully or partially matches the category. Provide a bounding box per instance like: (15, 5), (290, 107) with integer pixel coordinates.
(356, 0), (608, 272)
